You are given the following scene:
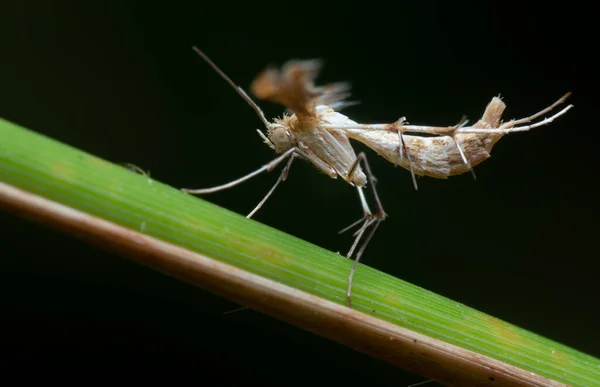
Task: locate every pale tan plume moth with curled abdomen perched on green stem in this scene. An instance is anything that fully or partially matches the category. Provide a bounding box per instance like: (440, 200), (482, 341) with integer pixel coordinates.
(183, 47), (573, 307)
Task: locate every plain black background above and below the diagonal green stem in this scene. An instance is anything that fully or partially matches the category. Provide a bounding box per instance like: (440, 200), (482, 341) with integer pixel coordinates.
(0, 0), (600, 386)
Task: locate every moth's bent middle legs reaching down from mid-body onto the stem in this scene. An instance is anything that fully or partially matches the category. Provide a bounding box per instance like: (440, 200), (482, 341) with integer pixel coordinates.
(346, 152), (387, 308)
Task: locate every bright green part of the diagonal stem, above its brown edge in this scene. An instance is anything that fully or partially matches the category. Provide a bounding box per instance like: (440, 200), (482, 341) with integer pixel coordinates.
(0, 120), (600, 386)
